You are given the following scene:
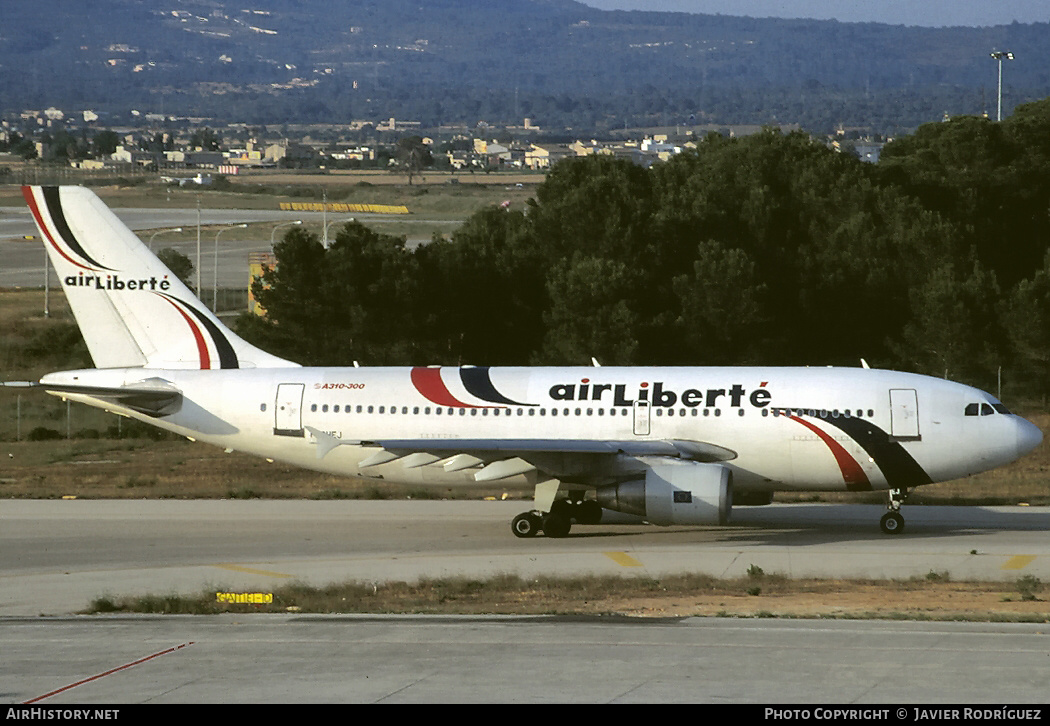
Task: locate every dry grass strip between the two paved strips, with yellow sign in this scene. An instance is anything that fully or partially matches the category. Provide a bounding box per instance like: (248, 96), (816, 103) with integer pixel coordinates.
(89, 574), (1050, 622)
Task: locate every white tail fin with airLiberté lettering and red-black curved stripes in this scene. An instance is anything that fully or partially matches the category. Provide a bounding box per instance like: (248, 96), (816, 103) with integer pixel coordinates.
(22, 186), (297, 370)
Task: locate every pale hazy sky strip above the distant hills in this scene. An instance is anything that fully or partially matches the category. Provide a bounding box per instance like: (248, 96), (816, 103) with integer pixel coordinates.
(581, 0), (1050, 26)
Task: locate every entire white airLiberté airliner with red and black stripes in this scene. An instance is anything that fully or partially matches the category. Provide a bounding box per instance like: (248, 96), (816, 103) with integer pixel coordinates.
(16, 187), (1043, 537)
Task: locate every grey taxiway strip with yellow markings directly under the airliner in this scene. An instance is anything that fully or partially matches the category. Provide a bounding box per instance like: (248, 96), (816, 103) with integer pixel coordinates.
(0, 500), (1050, 616)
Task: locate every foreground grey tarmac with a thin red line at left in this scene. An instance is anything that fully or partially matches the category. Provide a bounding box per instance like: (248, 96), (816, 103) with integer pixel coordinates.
(0, 615), (1050, 706)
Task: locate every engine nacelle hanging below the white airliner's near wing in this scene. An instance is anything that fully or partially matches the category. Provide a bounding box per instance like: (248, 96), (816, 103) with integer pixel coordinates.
(597, 459), (733, 524)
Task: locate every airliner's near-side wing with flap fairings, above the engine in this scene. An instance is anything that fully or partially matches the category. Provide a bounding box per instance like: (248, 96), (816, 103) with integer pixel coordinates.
(307, 427), (736, 481)
